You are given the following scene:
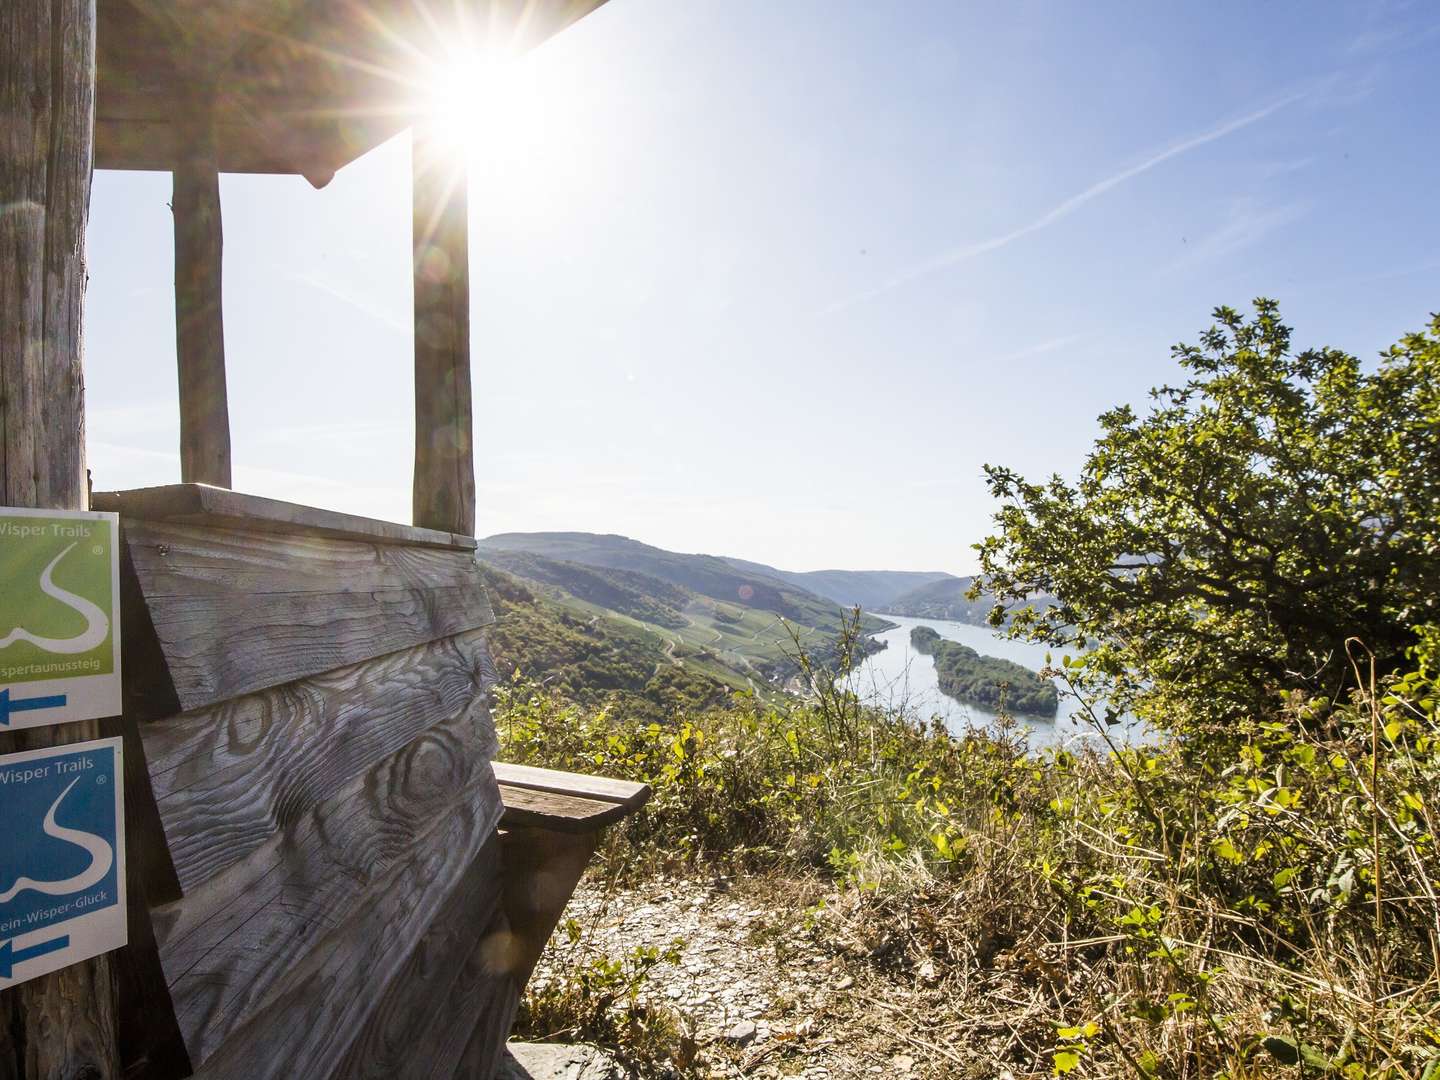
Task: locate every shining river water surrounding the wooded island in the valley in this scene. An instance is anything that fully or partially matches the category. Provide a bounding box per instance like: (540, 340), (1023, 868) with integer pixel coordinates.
(852, 613), (1126, 746)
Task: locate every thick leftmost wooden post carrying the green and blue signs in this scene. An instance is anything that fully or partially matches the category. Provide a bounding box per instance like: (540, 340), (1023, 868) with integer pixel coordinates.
(0, 0), (120, 1080)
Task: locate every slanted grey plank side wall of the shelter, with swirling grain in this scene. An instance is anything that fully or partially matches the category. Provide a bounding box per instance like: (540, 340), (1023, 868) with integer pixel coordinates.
(96, 492), (523, 1080)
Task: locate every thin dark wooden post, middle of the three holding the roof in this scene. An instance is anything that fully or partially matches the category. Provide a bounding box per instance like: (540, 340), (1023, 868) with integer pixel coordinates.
(170, 91), (230, 488)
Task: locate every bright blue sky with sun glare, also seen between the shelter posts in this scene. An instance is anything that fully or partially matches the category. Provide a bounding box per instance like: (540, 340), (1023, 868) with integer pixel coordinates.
(86, 0), (1440, 572)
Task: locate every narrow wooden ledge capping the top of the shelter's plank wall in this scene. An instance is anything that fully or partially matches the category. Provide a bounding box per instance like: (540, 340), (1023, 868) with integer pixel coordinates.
(91, 484), (477, 552)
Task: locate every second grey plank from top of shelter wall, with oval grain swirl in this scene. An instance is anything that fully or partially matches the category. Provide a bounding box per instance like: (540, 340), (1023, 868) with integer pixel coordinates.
(144, 631), (495, 891)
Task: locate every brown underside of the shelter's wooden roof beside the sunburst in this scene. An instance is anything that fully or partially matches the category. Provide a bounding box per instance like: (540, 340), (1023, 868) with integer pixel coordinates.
(95, 0), (605, 187)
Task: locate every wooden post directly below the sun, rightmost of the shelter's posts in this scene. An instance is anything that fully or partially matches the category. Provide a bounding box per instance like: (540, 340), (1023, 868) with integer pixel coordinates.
(410, 127), (475, 536)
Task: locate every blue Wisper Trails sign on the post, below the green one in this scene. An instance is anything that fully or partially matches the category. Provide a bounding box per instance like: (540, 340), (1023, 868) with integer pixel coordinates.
(0, 739), (125, 991)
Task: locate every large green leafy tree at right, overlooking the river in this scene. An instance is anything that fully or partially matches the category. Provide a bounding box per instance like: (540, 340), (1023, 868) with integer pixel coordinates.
(976, 300), (1440, 730)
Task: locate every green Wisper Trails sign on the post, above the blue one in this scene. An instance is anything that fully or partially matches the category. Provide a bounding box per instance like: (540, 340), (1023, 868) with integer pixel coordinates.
(0, 507), (120, 732)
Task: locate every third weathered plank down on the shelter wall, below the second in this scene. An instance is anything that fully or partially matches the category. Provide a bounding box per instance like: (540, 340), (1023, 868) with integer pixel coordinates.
(154, 701), (501, 1079)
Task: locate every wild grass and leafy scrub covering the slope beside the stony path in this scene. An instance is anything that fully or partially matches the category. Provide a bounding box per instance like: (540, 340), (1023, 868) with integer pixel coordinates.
(498, 624), (1440, 1080)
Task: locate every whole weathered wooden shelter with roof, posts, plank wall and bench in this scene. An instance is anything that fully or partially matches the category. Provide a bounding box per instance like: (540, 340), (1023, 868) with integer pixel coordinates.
(0, 0), (648, 1080)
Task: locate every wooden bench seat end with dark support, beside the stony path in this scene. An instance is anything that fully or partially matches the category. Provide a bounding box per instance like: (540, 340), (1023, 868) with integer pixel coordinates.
(491, 762), (651, 985)
